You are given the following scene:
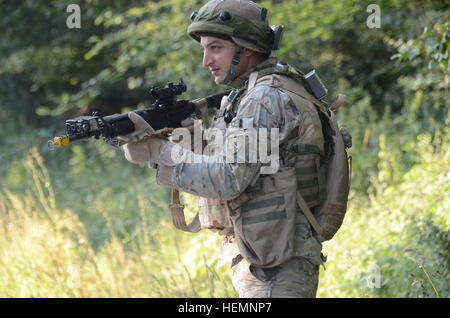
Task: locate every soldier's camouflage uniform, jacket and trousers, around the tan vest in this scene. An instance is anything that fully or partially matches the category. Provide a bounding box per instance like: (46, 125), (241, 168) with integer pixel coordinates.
(157, 59), (323, 297)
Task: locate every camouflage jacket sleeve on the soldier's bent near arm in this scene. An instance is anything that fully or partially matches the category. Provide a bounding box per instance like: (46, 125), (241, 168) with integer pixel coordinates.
(157, 85), (299, 200)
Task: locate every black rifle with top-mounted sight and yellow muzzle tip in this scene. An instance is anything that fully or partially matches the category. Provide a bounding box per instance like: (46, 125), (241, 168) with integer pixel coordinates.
(48, 78), (228, 150)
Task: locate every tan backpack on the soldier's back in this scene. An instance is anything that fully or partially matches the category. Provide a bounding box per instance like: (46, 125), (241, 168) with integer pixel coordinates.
(253, 64), (352, 242)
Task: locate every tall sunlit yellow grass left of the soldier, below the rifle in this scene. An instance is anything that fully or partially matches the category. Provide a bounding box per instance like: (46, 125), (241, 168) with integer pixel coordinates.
(0, 150), (235, 297)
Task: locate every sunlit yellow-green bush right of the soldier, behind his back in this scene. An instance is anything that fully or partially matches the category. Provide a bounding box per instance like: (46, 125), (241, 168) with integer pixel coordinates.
(318, 129), (450, 297)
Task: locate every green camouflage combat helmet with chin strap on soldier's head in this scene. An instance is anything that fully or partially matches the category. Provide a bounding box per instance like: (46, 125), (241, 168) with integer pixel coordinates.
(187, 0), (284, 84)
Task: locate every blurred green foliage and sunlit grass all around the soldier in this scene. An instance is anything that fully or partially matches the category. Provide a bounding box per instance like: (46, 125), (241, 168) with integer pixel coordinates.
(0, 0), (450, 297)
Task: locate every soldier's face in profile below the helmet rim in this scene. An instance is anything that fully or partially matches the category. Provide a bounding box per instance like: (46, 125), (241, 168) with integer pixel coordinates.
(200, 36), (236, 79)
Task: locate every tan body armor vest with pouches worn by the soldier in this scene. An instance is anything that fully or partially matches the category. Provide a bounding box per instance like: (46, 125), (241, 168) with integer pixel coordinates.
(198, 64), (325, 267)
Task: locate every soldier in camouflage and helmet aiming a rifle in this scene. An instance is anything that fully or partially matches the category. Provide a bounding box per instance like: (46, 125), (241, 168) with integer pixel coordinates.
(121, 0), (324, 297)
